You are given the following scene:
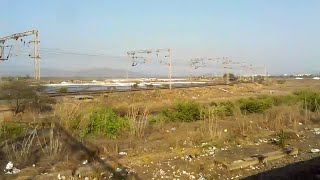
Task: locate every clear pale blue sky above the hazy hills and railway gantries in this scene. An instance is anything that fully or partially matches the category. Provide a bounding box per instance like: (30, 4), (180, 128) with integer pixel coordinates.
(0, 0), (320, 75)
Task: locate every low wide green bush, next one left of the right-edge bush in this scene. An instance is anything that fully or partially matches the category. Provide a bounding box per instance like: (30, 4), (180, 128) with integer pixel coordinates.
(239, 98), (273, 114)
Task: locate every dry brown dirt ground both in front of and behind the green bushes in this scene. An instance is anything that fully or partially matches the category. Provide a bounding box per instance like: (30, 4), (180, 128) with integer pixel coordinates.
(0, 80), (320, 180)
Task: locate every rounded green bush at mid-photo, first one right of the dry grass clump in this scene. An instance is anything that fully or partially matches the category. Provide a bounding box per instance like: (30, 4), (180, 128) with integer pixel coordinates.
(161, 101), (201, 122)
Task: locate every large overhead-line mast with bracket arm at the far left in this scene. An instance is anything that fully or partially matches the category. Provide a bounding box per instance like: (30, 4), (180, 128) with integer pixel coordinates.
(0, 30), (40, 80)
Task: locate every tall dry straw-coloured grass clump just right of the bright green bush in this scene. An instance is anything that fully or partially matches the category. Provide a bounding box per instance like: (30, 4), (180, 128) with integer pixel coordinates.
(127, 106), (149, 138)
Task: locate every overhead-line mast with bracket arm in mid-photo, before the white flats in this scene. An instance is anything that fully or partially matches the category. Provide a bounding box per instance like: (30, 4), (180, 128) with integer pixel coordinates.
(127, 48), (172, 91)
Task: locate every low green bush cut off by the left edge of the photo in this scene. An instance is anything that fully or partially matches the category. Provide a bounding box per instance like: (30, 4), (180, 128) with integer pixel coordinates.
(0, 122), (26, 139)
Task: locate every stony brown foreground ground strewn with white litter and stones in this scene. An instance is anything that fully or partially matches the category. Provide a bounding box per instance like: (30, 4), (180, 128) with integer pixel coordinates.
(0, 122), (320, 179)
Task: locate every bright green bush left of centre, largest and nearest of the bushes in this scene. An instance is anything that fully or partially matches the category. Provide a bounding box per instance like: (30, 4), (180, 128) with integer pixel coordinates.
(81, 107), (128, 138)
